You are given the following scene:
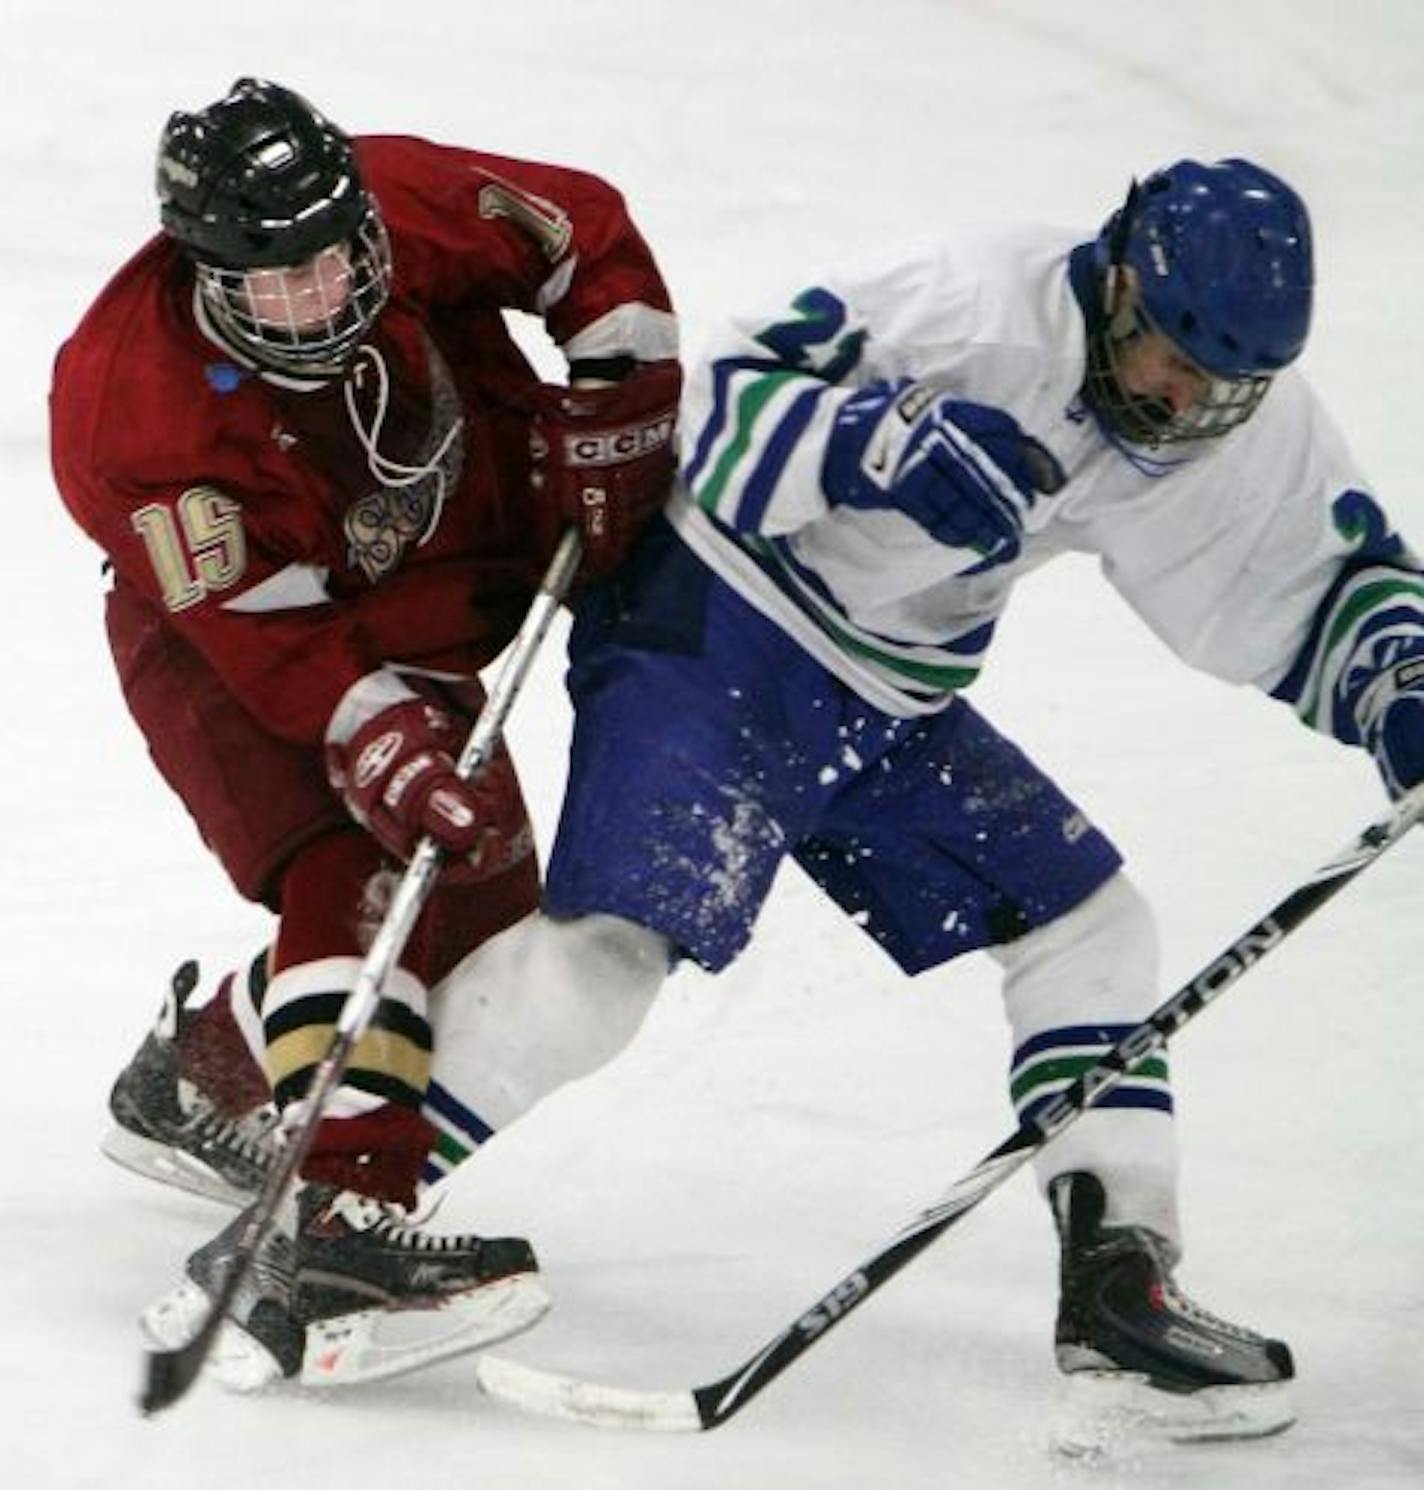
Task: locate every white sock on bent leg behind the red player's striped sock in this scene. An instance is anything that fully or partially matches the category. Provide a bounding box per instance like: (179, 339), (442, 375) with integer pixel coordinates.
(425, 913), (669, 1179)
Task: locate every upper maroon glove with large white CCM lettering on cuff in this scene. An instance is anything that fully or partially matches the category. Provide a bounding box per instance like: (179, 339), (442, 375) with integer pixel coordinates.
(530, 362), (682, 580)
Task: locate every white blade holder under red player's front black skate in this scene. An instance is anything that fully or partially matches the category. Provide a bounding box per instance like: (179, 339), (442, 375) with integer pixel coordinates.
(301, 1272), (550, 1387)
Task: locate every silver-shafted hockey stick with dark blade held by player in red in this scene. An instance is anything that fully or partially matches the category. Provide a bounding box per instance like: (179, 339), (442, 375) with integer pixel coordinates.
(139, 529), (582, 1414)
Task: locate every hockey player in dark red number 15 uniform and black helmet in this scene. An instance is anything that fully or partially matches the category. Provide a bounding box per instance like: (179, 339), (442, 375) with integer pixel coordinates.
(52, 79), (679, 1384)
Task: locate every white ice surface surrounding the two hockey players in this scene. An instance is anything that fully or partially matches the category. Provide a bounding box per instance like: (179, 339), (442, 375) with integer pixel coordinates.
(0, 0), (1424, 1490)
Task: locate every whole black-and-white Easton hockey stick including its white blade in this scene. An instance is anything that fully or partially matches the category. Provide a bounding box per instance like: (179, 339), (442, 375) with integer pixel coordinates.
(477, 785), (1424, 1432)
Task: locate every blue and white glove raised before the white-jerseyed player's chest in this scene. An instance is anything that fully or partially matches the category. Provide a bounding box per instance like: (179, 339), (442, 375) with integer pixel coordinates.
(821, 380), (1064, 572)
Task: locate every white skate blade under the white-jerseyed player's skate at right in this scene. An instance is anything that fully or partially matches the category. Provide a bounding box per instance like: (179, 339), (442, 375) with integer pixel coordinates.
(1049, 1371), (1296, 1460)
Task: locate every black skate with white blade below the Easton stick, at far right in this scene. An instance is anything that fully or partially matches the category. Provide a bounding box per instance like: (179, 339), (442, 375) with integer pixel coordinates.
(1049, 1173), (1294, 1441)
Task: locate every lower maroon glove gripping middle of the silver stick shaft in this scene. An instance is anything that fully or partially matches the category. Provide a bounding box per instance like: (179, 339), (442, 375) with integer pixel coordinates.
(326, 699), (529, 876)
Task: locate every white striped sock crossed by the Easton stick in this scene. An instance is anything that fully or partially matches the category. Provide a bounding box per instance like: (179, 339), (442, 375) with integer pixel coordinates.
(994, 873), (1181, 1249)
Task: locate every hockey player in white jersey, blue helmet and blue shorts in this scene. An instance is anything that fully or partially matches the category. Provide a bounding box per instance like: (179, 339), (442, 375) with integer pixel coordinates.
(436, 159), (1424, 1438)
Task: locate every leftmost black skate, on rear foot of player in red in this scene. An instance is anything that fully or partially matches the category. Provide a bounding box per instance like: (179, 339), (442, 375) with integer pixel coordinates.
(101, 963), (277, 1205)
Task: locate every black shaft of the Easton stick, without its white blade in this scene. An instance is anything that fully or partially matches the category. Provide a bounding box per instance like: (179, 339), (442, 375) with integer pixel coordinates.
(691, 785), (1424, 1429)
